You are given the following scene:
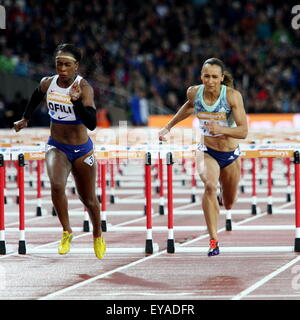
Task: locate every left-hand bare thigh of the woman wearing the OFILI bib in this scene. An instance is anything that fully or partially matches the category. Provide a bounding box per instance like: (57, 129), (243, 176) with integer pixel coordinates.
(45, 148), (72, 185)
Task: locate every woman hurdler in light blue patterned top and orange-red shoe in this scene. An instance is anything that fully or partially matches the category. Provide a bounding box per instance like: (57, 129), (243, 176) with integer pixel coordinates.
(159, 58), (248, 256)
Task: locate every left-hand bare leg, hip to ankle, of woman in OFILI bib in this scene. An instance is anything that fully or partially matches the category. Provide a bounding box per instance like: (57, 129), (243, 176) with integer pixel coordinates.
(46, 148), (72, 233)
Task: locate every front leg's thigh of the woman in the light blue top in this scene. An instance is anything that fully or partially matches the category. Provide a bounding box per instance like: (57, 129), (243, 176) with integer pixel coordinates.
(196, 151), (220, 185)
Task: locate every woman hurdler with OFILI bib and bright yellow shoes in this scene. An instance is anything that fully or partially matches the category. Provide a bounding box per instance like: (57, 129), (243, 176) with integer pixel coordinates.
(14, 44), (106, 259)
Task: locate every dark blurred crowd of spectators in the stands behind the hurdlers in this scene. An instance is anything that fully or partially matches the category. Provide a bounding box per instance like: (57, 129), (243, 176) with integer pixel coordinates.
(0, 0), (300, 125)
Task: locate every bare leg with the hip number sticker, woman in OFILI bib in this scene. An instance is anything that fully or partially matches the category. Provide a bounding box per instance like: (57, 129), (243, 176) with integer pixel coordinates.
(72, 151), (101, 237)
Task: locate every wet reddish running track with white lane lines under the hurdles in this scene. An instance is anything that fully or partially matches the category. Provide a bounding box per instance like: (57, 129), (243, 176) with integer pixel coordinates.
(0, 159), (300, 300)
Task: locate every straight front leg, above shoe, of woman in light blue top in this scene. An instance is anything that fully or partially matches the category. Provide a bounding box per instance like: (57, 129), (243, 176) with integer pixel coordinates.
(196, 151), (220, 240)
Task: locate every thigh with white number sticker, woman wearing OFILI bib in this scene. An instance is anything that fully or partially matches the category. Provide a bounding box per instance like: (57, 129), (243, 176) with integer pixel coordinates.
(72, 151), (97, 198)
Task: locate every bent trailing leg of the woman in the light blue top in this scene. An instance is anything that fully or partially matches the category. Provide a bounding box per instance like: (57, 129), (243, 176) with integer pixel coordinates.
(220, 158), (241, 210)
